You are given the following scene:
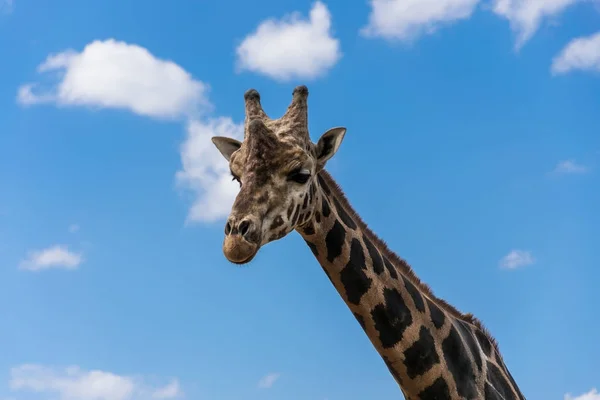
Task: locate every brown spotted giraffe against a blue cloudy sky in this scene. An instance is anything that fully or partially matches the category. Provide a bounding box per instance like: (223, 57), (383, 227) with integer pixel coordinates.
(212, 86), (525, 400)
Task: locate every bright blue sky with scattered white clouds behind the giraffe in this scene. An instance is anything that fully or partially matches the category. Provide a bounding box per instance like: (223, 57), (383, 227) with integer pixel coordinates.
(0, 0), (600, 400)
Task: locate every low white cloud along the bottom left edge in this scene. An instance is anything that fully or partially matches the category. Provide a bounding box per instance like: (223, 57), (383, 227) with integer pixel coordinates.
(9, 364), (183, 400)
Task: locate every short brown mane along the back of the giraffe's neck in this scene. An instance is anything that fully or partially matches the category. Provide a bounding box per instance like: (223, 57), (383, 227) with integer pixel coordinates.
(319, 169), (502, 359)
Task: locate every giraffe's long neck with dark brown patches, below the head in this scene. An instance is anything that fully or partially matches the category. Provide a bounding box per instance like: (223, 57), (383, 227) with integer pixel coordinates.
(298, 171), (524, 400)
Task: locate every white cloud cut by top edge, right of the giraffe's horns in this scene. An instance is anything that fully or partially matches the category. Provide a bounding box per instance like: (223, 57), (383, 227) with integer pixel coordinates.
(361, 0), (479, 42)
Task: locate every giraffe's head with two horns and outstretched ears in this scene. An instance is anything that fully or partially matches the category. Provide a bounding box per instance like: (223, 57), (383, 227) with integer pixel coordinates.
(212, 86), (346, 264)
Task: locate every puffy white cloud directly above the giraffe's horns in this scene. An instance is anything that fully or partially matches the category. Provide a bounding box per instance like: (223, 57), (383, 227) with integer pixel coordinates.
(236, 1), (342, 81)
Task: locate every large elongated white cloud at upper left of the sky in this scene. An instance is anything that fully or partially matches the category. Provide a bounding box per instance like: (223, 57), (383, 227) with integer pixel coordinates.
(17, 39), (210, 119)
